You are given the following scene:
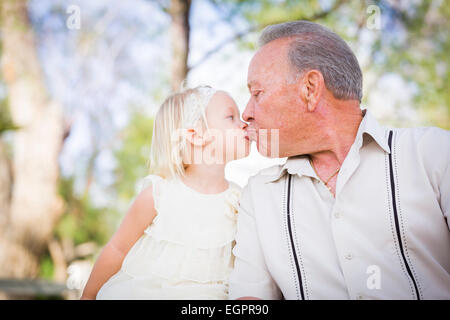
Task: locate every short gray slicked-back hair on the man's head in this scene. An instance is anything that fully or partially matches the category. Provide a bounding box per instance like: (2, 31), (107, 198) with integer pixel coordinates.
(259, 20), (362, 102)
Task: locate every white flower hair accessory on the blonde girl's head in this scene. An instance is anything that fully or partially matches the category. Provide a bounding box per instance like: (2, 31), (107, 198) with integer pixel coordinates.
(184, 86), (217, 128)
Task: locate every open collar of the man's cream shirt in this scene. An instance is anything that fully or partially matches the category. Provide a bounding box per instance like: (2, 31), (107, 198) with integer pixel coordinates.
(264, 109), (391, 183)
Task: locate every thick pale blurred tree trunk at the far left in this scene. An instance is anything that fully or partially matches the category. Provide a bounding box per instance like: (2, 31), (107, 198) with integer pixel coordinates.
(0, 0), (64, 277)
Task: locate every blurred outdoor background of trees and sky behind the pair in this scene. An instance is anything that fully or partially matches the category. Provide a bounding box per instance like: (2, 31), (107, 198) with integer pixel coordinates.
(0, 0), (450, 298)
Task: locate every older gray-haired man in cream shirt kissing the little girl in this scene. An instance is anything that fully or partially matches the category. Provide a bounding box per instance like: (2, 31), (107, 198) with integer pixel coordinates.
(229, 21), (450, 299)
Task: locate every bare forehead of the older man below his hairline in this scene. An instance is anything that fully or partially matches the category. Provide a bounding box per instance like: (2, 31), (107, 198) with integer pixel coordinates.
(247, 38), (289, 88)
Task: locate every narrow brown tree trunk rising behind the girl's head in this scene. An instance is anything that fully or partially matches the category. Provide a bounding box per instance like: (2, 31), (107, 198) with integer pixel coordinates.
(169, 0), (191, 91)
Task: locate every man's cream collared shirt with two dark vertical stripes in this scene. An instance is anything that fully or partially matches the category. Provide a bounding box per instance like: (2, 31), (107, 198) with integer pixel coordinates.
(229, 110), (450, 299)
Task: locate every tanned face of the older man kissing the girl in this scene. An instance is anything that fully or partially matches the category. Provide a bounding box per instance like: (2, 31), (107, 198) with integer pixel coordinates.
(242, 39), (310, 157)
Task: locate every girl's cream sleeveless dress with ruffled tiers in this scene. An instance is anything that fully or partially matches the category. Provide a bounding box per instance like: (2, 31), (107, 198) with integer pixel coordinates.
(97, 175), (241, 300)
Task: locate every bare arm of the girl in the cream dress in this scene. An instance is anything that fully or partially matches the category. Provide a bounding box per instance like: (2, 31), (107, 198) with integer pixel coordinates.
(81, 186), (156, 300)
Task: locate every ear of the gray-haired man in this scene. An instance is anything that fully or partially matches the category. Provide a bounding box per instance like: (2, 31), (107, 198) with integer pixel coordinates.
(300, 69), (325, 112)
